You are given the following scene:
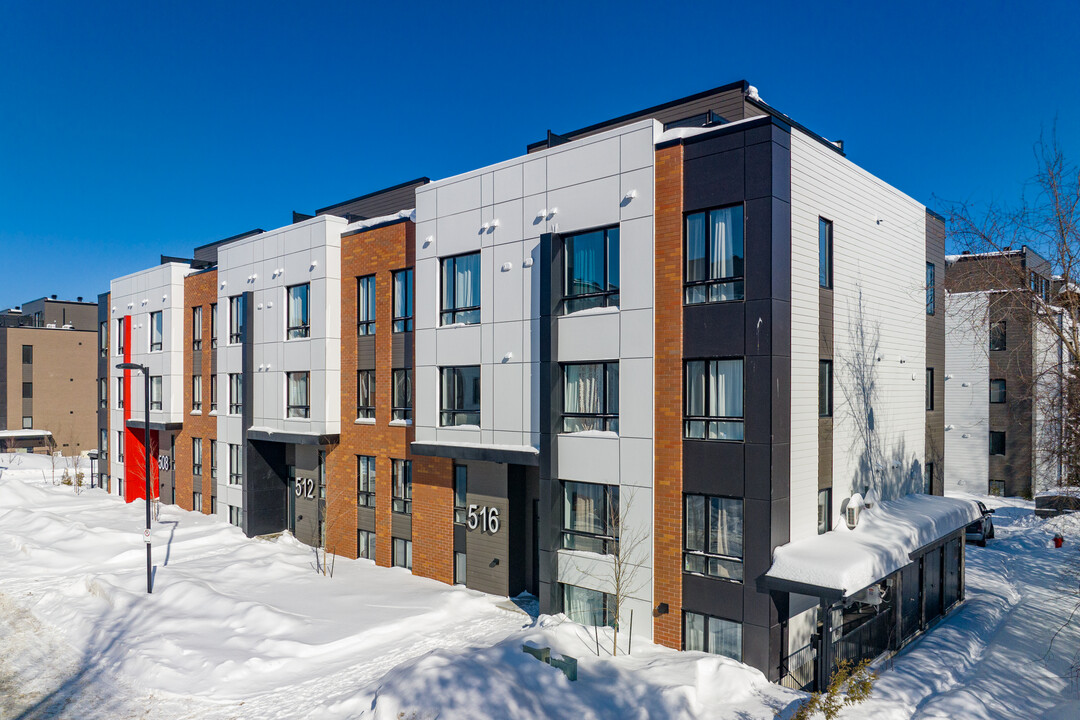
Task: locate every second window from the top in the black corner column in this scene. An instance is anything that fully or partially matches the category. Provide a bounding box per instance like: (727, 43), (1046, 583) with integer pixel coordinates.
(684, 359), (743, 440)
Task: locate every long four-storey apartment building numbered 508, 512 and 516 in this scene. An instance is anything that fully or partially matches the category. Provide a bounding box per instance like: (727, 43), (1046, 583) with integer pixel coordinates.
(108, 82), (973, 687)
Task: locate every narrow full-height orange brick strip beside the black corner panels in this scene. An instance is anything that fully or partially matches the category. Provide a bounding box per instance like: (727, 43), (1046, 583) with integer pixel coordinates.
(652, 145), (683, 649)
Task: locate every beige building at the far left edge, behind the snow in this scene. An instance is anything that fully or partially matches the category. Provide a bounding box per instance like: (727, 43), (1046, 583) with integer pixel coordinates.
(0, 301), (98, 454)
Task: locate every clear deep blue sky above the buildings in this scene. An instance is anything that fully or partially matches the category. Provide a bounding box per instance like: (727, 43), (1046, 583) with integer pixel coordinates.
(0, 0), (1080, 308)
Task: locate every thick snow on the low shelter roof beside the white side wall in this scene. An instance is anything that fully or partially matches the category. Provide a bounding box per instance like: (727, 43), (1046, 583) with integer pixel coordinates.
(766, 494), (980, 597)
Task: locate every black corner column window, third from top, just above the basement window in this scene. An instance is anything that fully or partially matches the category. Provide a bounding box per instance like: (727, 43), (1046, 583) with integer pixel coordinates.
(683, 494), (743, 581)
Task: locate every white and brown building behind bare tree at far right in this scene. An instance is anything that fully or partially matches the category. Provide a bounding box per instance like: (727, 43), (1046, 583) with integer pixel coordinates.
(945, 246), (1070, 498)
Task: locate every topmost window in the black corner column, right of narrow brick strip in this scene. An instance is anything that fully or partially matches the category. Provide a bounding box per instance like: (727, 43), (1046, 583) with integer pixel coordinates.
(686, 205), (743, 304)
